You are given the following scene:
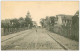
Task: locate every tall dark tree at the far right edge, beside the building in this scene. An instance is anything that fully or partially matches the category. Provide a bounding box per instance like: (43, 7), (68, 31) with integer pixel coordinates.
(72, 11), (79, 41)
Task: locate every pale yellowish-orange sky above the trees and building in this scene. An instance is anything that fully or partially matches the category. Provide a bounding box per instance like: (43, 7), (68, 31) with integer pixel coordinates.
(1, 1), (79, 25)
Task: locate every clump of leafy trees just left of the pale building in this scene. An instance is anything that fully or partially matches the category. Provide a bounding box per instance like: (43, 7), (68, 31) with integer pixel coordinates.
(40, 16), (55, 30)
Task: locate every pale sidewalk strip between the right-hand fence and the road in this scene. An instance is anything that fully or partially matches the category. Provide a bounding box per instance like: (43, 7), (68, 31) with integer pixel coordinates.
(48, 31), (79, 50)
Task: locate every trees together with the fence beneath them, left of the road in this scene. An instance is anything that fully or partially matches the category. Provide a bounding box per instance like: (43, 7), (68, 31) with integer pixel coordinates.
(1, 12), (33, 35)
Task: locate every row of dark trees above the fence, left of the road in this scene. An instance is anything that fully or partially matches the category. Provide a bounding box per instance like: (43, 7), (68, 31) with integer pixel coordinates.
(1, 11), (33, 28)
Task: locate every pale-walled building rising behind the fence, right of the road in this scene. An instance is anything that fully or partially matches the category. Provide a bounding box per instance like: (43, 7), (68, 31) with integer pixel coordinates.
(56, 14), (72, 26)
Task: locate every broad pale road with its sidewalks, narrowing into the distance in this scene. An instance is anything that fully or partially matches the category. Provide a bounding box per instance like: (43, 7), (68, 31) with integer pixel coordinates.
(1, 29), (79, 50)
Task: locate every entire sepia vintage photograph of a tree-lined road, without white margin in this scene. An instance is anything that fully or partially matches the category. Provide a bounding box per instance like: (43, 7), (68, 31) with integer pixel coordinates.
(1, 1), (79, 51)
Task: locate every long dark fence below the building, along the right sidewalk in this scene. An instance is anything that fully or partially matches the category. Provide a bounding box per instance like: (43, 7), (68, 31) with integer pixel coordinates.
(48, 27), (79, 41)
